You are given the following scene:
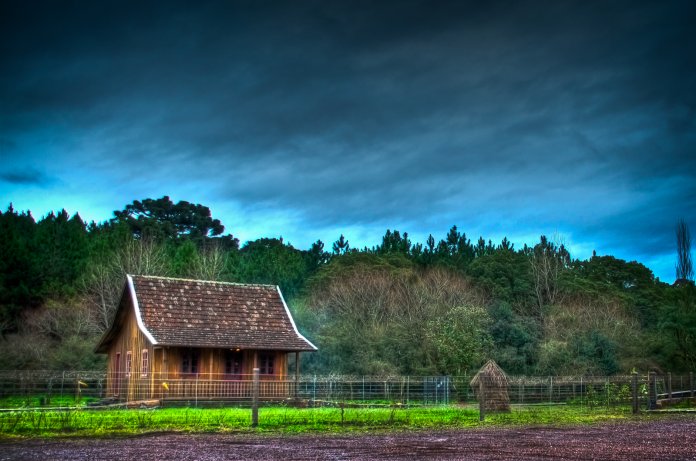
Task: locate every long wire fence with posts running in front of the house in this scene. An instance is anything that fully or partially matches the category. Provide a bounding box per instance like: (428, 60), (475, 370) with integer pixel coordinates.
(0, 371), (696, 409)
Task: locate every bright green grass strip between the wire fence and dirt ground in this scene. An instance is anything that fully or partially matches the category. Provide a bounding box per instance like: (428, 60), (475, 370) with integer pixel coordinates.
(0, 405), (633, 438)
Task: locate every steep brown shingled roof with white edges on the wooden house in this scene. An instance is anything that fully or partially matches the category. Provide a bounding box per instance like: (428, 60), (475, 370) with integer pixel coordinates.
(97, 275), (317, 352)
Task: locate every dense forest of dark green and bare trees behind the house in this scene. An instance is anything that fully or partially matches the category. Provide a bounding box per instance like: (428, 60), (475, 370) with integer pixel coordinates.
(0, 196), (696, 375)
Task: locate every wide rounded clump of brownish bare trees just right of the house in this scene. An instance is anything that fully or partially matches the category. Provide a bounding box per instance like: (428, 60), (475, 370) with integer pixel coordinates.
(307, 266), (488, 374)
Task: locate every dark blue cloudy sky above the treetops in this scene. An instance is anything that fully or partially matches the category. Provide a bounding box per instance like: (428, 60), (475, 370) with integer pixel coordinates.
(0, 0), (696, 281)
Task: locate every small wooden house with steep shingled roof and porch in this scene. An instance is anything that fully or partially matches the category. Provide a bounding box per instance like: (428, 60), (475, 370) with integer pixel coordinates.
(96, 275), (317, 401)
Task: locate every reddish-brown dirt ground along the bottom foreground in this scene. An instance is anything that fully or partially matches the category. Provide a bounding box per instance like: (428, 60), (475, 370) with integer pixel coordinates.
(0, 416), (696, 461)
